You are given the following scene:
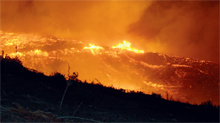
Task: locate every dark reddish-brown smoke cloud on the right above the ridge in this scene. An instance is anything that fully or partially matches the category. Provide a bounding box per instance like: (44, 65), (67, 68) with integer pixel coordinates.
(128, 1), (219, 62)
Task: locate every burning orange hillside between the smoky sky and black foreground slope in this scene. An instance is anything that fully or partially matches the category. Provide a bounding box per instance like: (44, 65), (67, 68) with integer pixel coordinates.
(1, 31), (219, 105)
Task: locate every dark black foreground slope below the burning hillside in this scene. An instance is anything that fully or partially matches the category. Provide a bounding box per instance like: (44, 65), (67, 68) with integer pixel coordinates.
(1, 58), (219, 122)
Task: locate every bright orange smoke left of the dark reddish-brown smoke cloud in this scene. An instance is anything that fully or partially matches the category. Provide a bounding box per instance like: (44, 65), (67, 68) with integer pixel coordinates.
(1, 0), (151, 45)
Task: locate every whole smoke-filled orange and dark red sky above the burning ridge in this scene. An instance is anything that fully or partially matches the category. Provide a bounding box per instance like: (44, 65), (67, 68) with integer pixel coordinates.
(1, 0), (219, 62)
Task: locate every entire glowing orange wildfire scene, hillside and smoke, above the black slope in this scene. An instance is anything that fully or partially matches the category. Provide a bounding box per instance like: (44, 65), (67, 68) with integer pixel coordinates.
(0, 0), (219, 104)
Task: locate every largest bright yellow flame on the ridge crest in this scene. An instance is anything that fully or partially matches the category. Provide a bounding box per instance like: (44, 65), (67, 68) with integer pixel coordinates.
(112, 40), (144, 53)
